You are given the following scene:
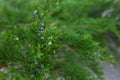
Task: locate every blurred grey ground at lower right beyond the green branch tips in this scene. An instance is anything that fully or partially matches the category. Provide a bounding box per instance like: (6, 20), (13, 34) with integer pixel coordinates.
(101, 33), (120, 80)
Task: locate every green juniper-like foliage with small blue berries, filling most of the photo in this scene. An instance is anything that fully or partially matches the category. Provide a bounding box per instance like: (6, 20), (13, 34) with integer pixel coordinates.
(0, 0), (120, 80)
